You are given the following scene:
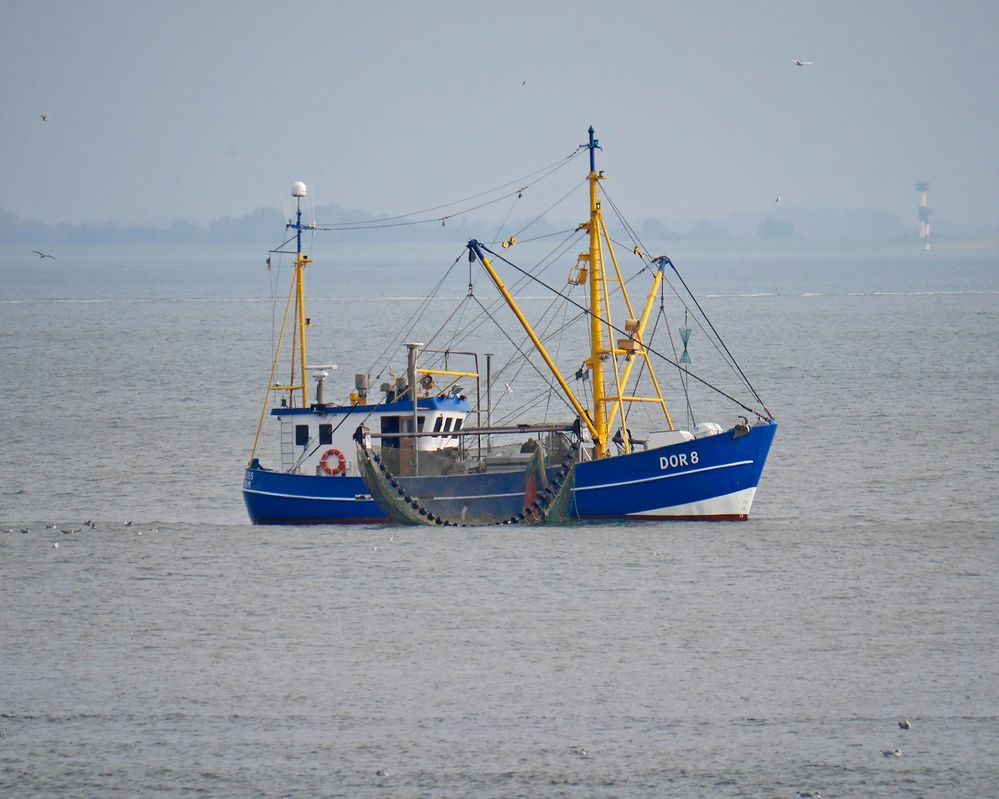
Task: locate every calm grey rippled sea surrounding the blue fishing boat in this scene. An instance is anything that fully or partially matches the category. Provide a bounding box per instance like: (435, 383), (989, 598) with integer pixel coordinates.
(0, 245), (999, 799)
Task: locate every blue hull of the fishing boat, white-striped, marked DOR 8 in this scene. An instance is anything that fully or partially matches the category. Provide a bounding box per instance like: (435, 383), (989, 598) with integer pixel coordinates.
(243, 422), (777, 524)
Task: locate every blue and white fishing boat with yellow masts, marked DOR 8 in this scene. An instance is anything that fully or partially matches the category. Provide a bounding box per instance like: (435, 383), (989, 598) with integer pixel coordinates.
(242, 128), (777, 526)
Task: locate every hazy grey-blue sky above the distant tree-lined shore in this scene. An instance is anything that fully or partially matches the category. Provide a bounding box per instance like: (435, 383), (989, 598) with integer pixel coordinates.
(0, 0), (999, 225)
